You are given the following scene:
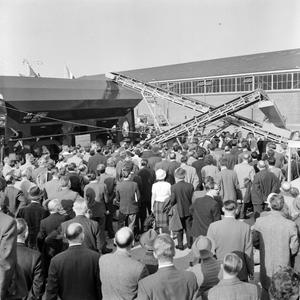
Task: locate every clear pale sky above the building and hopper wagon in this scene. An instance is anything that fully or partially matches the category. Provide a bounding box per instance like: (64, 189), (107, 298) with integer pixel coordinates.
(0, 0), (300, 77)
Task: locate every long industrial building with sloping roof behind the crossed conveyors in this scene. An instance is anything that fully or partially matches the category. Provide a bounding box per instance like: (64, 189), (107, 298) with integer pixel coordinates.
(122, 49), (300, 130)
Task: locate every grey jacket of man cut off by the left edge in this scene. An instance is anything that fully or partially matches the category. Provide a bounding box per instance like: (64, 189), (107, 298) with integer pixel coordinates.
(0, 211), (28, 299)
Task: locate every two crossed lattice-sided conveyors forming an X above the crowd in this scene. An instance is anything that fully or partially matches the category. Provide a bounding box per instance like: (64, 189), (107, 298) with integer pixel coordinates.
(106, 73), (287, 144)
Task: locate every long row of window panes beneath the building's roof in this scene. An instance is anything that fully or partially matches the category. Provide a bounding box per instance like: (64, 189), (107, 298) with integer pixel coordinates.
(156, 73), (300, 94)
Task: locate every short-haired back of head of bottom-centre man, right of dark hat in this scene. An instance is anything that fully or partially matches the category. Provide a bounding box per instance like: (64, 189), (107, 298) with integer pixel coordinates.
(153, 233), (175, 263)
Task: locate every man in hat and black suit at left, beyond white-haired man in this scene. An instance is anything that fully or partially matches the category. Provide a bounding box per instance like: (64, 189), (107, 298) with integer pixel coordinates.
(17, 186), (49, 250)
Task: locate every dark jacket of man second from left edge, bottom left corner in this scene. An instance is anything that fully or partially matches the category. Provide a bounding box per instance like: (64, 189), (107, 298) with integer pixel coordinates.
(17, 243), (45, 300)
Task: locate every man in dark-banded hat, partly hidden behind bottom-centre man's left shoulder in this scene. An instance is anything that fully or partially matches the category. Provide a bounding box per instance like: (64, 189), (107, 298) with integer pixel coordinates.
(139, 229), (158, 275)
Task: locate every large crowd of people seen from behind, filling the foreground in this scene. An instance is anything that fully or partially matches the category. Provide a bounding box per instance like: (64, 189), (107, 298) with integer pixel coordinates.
(0, 131), (300, 300)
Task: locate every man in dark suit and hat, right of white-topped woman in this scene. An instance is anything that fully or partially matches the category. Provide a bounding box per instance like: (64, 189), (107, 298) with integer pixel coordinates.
(170, 168), (194, 250)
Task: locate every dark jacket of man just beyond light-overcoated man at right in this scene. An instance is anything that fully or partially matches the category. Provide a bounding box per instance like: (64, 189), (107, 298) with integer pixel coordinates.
(251, 170), (280, 204)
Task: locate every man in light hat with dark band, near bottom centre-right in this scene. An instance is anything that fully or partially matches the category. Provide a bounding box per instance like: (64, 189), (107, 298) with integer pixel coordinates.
(188, 235), (222, 299)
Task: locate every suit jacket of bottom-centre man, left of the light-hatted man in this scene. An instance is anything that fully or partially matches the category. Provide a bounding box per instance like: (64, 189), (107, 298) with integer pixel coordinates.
(138, 266), (198, 300)
